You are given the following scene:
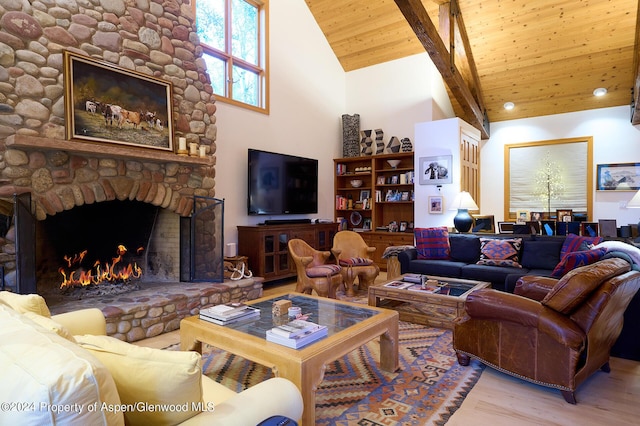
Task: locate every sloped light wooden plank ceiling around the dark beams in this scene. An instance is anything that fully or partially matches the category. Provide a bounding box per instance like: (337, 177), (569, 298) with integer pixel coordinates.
(306, 0), (638, 133)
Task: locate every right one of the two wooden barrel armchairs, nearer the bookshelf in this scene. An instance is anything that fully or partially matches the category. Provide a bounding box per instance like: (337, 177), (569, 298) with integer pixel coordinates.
(331, 231), (380, 296)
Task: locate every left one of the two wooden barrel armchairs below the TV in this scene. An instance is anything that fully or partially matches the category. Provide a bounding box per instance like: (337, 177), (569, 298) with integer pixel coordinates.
(288, 238), (342, 299)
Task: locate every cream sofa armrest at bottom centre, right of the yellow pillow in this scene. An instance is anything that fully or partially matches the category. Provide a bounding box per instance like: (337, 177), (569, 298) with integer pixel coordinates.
(182, 377), (303, 426)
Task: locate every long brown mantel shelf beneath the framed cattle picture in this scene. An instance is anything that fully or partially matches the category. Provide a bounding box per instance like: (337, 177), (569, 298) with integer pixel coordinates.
(5, 134), (215, 166)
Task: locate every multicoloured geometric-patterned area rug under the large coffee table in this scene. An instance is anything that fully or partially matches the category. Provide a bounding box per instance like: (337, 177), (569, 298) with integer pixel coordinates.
(203, 321), (483, 426)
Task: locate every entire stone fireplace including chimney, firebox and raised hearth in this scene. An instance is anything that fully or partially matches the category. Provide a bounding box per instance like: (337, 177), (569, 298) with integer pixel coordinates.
(0, 0), (268, 341)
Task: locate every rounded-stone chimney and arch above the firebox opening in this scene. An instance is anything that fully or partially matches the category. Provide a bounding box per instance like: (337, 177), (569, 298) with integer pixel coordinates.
(0, 0), (216, 290)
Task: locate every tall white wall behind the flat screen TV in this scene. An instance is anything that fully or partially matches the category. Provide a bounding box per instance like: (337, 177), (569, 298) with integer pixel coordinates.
(216, 0), (345, 243)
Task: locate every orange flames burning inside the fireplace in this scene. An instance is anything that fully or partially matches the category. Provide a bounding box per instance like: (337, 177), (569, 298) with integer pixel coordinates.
(58, 244), (144, 289)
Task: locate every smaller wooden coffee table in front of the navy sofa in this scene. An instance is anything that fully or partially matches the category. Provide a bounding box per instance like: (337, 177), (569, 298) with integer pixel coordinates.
(369, 275), (491, 329)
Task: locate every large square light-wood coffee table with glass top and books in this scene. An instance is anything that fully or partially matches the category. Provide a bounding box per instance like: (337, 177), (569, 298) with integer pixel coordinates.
(180, 293), (398, 426)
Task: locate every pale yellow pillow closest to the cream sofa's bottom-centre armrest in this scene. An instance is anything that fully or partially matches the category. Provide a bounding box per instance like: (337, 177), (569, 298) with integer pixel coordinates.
(75, 335), (202, 425)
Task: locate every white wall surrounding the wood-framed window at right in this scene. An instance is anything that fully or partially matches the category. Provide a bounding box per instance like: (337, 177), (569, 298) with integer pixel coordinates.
(479, 106), (640, 226)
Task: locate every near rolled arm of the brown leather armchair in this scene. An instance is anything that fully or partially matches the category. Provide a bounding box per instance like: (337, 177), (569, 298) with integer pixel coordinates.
(465, 289), (586, 350)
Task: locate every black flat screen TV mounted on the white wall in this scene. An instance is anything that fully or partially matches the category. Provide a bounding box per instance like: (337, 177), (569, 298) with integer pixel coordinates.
(247, 149), (318, 215)
